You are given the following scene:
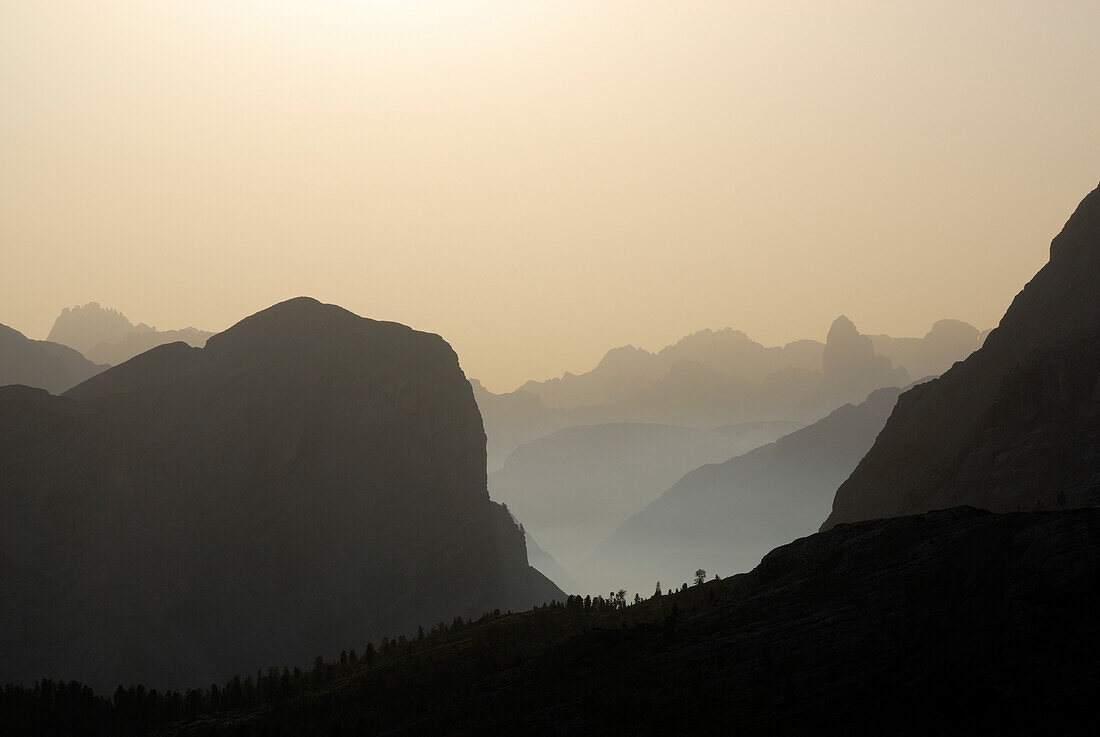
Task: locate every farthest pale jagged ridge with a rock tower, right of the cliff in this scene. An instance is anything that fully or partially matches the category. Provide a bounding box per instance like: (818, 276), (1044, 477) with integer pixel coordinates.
(475, 316), (982, 471)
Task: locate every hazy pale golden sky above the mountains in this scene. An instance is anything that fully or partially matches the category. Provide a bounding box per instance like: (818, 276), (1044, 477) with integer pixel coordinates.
(0, 0), (1100, 391)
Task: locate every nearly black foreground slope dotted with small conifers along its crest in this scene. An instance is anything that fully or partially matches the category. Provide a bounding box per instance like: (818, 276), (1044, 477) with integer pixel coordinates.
(0, 508), (1100, 736)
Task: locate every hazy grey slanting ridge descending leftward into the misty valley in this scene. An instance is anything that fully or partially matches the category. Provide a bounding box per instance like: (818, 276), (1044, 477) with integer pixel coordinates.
(594, 387), (901, 592)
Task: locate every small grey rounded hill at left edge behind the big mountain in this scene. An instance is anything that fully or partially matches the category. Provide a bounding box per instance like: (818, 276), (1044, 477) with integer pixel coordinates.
(0, 325), (107, 394)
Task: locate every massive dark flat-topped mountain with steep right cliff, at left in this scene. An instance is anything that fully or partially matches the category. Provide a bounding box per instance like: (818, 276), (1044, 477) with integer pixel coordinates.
(0, 298), (562, 688)
